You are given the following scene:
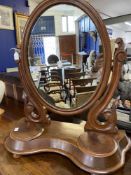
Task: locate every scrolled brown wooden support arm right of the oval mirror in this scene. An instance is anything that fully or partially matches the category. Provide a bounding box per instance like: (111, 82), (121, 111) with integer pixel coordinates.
(85, 39), (126, 133)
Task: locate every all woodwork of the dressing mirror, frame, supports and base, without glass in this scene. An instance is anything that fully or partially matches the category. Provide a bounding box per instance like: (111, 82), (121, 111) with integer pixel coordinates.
(5, 0), (131, 175)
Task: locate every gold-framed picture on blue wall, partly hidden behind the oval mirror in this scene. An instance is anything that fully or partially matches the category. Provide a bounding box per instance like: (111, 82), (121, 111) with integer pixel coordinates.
(15, 13), (29, 47)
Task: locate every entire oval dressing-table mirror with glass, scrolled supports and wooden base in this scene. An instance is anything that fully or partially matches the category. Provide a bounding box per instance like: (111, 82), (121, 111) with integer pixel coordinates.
(5, 0), (131, 175)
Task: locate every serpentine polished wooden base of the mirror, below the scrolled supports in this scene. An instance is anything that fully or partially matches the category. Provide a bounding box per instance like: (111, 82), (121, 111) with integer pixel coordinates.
(5, 121), (131, 174)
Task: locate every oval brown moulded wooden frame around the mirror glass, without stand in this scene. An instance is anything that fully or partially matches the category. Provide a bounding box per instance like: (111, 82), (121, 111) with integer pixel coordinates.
(19, 0), (112, 116)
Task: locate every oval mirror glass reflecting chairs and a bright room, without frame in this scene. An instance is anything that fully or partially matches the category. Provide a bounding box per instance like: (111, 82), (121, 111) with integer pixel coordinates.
(28, 4), (104, 109)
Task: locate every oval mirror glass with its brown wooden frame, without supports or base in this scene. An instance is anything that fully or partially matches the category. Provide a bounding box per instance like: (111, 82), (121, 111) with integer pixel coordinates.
(22, 0), (111, 114)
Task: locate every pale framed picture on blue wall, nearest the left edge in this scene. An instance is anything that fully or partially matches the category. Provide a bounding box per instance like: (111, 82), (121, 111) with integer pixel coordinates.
(0, 5), (14, 30)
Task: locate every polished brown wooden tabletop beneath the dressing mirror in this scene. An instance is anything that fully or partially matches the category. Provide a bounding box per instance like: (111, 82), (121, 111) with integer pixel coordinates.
(0, 99), (131, 175)
